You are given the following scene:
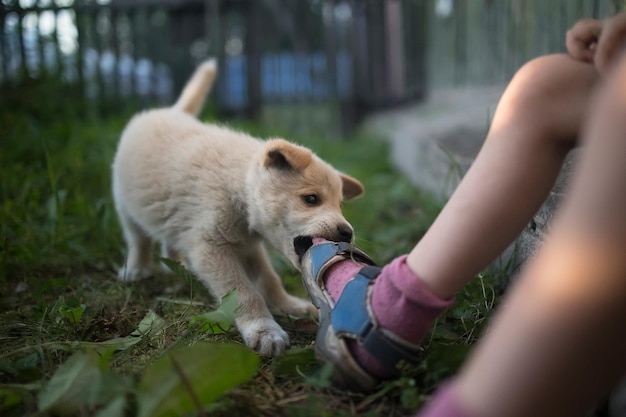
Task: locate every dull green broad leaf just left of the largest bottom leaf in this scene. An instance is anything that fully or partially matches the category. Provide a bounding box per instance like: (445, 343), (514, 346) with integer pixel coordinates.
(37, 352), (101, 415)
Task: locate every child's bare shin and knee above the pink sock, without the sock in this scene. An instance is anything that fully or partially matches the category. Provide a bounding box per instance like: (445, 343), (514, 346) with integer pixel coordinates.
(407, 55), (597, 298)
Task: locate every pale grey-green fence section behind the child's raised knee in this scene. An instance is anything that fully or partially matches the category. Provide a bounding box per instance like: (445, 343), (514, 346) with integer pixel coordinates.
(426, 0), (623, 88)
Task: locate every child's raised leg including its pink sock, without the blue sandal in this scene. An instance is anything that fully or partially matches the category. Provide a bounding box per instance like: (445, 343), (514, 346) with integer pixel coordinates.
(302, 55), (597, 386)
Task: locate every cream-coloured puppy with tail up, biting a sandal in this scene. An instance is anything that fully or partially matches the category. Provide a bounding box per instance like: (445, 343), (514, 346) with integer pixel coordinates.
(112, 60), (363, 356)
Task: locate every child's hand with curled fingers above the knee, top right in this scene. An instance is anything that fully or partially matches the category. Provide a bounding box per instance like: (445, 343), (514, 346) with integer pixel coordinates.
(565, 13), (626, 74)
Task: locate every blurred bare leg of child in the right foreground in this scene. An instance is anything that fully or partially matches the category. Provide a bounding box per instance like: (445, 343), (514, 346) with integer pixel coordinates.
(420, 51), (626, 417)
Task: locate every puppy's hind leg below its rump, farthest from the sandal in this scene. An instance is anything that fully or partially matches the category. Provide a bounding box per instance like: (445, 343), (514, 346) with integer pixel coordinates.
(117, 209), (152, 281)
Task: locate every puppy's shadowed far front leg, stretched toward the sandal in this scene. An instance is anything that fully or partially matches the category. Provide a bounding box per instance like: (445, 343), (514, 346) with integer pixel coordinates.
(245, 243), (317, 316)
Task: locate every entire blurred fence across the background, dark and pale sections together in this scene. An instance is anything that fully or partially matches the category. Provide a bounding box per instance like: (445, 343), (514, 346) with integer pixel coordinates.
(0, 0), (621, 132)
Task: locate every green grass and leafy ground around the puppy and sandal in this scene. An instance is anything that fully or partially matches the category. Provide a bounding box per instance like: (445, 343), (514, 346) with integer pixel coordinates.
(0, 76), (497, 417)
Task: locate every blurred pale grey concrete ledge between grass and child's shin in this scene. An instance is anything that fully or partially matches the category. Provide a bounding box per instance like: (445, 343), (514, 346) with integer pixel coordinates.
(366, 86), (504, 200)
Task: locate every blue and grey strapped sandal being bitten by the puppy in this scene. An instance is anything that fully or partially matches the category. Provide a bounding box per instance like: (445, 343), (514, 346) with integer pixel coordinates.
(302, 242), (420, 391)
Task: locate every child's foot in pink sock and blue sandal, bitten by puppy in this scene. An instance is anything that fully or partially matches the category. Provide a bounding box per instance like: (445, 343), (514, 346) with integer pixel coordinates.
(302, 239), (453, 390)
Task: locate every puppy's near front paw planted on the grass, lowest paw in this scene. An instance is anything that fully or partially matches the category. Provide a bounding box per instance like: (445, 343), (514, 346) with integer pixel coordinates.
(237, 317), (289, 356)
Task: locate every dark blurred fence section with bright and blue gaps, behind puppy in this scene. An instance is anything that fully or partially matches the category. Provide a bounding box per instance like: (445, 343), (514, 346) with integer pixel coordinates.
(0, 0), (425, 132)
